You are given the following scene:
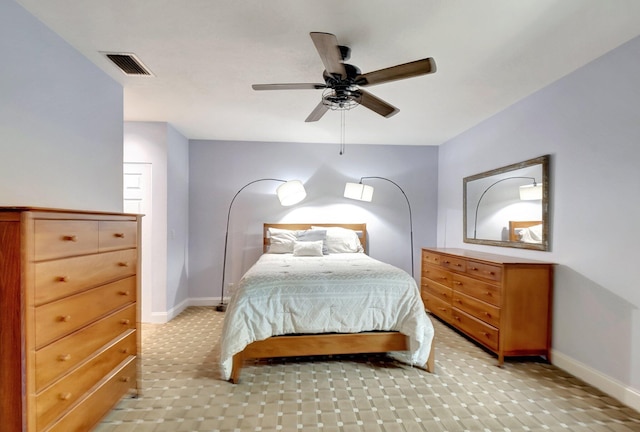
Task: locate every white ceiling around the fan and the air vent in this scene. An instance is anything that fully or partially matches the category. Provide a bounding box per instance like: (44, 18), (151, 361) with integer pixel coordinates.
(17, 0), (640, 145)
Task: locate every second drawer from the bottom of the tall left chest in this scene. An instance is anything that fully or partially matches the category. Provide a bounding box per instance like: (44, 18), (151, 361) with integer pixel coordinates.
(36, 330), (136, 429)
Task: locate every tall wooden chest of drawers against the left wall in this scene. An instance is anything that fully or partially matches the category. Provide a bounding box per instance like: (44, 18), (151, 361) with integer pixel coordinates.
(0, 207), (140, 432)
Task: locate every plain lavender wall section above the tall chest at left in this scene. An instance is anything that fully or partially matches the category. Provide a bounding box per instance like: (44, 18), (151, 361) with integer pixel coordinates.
(0, 1), (123, 211)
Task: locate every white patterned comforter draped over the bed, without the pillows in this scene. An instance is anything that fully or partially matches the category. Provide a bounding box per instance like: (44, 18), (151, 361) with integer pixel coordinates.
(220, 253), (434, 379)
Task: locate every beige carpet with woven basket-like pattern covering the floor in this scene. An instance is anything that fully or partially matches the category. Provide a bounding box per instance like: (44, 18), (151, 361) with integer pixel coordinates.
(96, 307), (640, 432)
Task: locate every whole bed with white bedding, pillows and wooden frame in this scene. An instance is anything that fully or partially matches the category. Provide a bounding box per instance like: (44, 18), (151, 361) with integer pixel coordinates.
(220, 224), (435, 383)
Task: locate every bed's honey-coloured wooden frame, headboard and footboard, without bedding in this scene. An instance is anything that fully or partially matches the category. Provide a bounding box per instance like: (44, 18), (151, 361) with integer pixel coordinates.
(230, 223), (435, 383)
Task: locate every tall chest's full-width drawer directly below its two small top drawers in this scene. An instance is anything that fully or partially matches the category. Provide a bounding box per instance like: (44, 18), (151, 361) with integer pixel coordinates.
(35, 249), (138, 305)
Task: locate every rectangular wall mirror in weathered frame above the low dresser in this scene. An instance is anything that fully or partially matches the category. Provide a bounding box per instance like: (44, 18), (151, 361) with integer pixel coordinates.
(463, 155), (549, 251)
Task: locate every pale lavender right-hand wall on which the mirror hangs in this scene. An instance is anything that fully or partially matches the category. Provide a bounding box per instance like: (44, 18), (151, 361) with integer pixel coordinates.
(438, 38), (640, 407)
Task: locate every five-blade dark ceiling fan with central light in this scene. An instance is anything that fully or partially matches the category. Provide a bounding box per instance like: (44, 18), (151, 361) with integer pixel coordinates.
(252, 32), (436, 122)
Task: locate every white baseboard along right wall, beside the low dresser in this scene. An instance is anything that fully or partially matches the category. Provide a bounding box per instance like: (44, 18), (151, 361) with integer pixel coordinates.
(551, 351), (640, 411)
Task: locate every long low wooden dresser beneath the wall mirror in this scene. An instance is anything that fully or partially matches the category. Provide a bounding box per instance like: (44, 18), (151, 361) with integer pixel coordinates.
(421, 248), (553, 365)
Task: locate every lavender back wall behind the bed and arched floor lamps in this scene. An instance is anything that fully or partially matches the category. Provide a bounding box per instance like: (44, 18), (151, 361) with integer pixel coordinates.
(189, 141), (438, 304)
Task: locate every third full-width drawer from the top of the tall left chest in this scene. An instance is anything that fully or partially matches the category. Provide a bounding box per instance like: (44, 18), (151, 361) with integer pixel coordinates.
(35, 304), (136, 392)
